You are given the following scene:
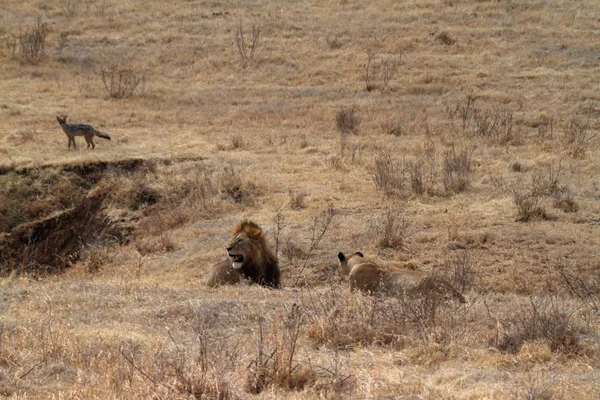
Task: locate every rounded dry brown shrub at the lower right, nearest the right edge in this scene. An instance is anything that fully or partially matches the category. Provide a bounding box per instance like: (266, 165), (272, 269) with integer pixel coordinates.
(498, 297), (585, 355)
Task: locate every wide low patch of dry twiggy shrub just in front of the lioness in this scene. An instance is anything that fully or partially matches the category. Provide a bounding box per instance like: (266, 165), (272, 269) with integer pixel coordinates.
(303, 286), (468, 348)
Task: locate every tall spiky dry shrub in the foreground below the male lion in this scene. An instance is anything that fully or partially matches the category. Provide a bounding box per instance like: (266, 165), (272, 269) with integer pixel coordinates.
(246, 304), (315, 394)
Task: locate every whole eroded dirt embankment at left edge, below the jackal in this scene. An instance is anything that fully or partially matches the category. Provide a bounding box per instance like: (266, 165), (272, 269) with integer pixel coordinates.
(0, 158), (204, 275)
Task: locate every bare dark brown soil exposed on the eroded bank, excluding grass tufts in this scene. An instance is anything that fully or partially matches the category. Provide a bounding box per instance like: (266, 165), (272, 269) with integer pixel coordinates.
(0, 158), (200, 275)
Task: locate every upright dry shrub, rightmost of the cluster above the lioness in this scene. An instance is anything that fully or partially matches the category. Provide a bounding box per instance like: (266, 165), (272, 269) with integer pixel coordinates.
(442, 145), (474, 193)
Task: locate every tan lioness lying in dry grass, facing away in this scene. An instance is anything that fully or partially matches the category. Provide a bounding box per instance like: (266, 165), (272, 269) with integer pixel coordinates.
(338, 251), (466, 303)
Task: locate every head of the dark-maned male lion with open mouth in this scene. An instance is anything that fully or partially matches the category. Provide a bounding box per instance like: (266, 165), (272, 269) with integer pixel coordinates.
(227, 221), (262, 269)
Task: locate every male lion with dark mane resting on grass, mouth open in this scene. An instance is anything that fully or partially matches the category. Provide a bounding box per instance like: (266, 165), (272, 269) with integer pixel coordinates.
(206, 220), (280, 288)
